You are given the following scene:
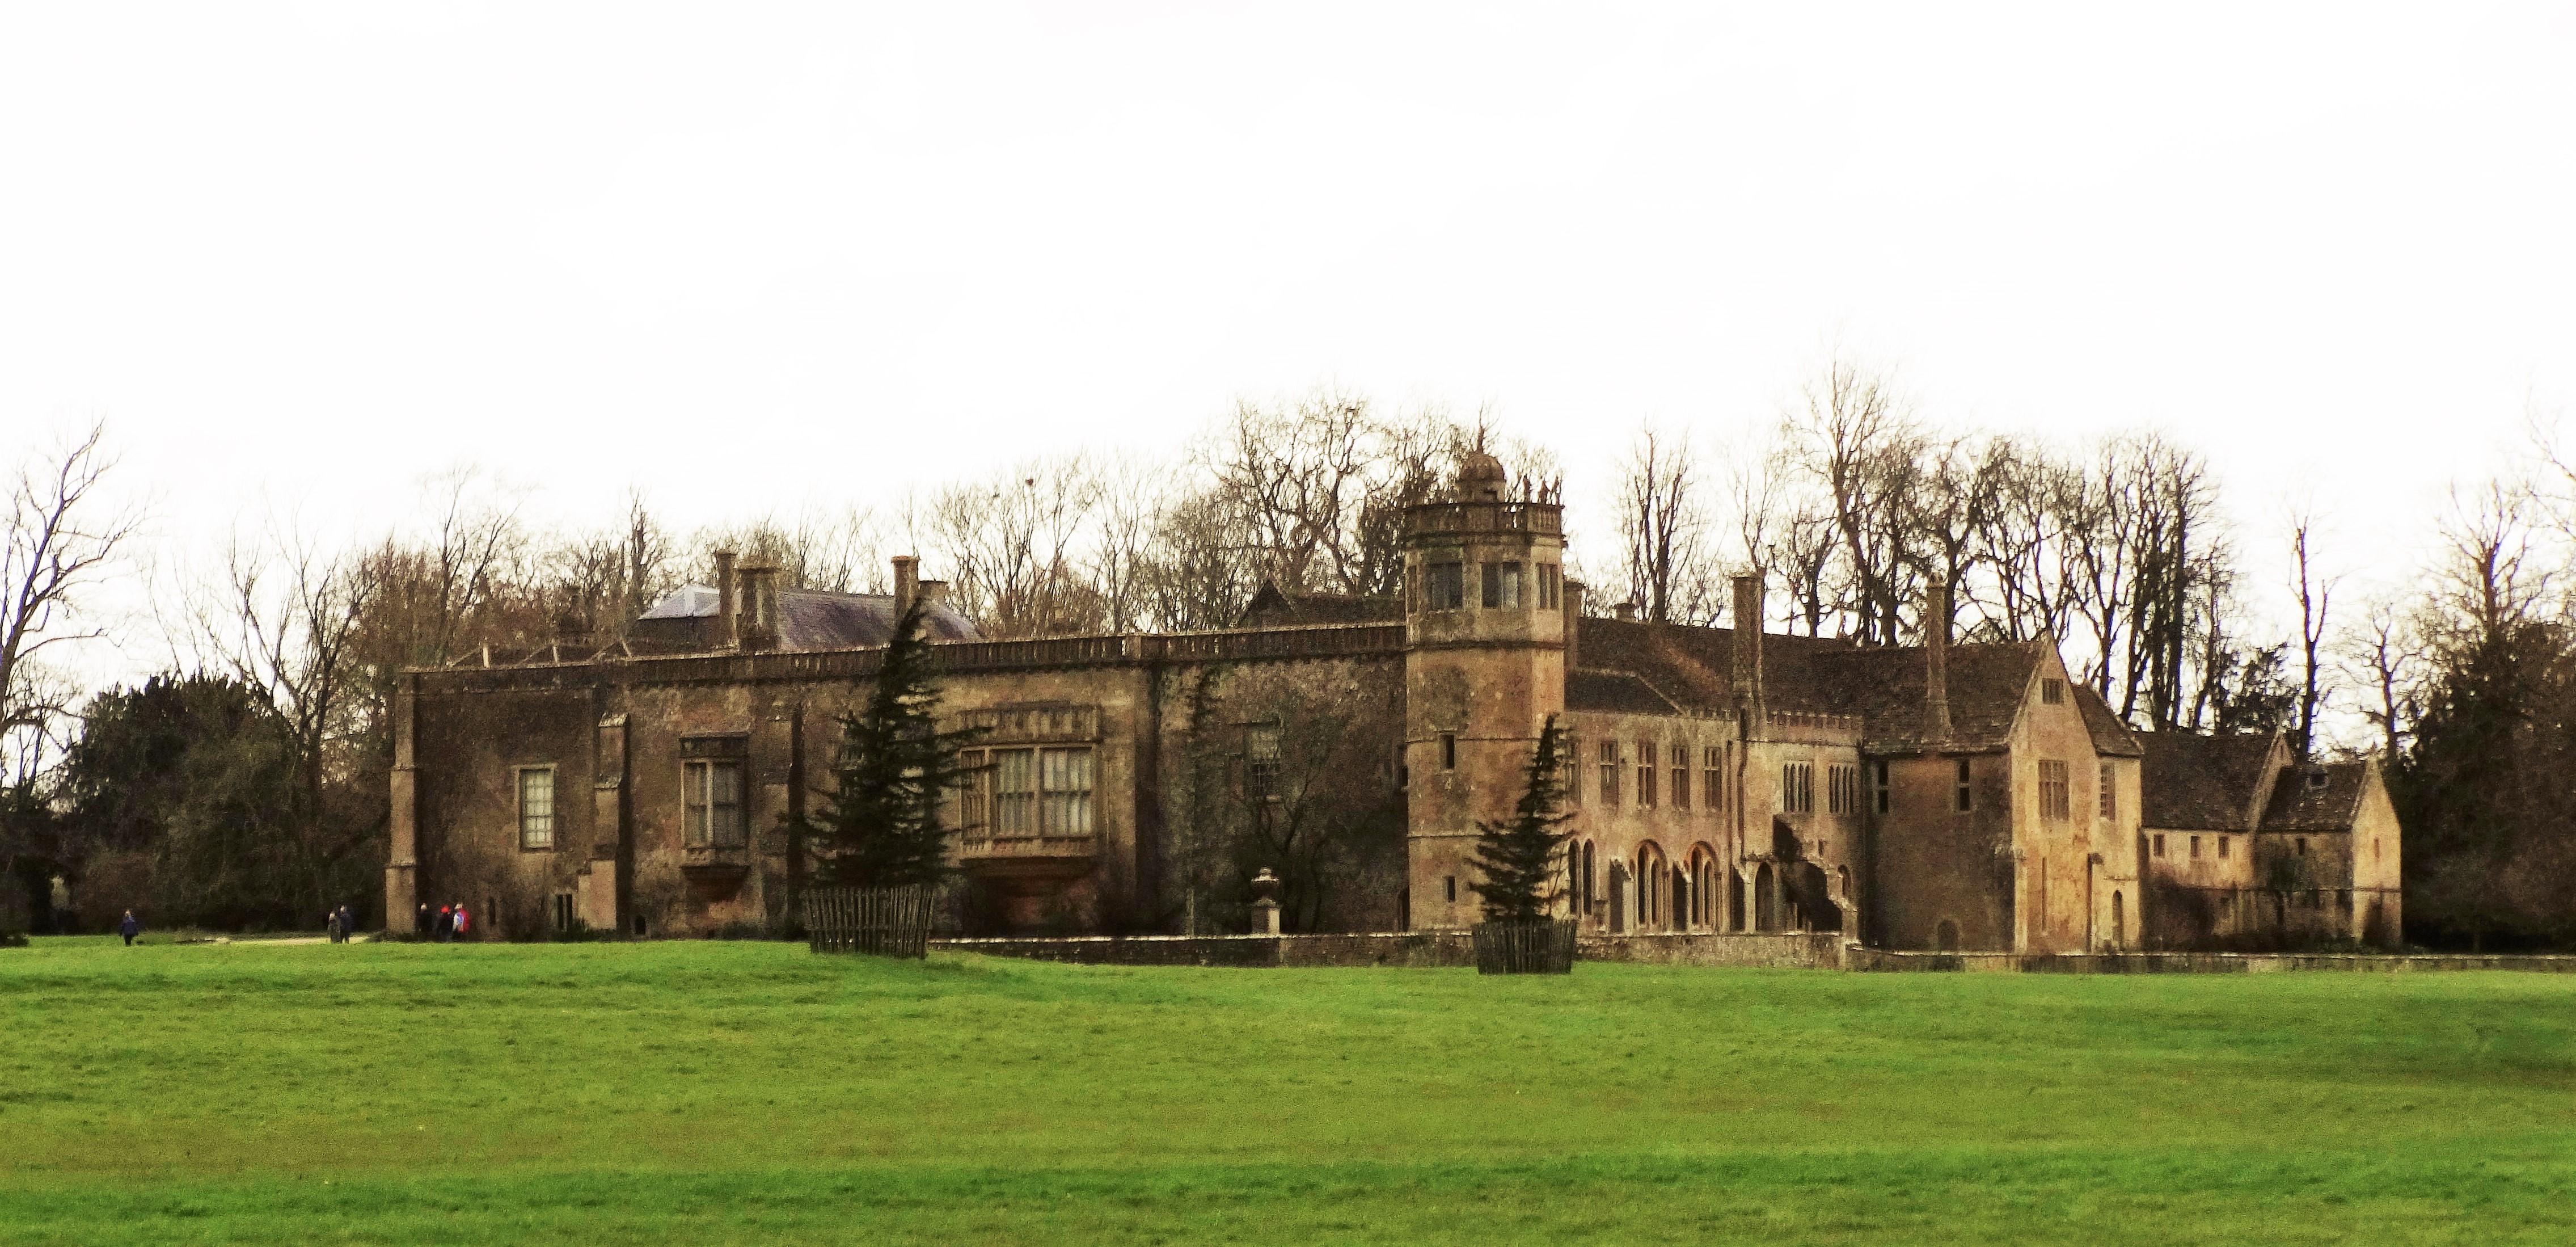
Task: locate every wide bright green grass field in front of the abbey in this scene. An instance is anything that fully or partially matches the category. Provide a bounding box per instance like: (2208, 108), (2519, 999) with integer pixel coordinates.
(0, 941), (2576, 1244)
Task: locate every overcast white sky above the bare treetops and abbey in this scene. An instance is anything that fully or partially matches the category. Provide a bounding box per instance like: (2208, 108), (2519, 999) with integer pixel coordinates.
(0, 3), (2576, 680)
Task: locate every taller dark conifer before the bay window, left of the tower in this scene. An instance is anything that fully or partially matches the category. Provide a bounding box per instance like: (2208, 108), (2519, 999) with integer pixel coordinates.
(806, 600), (984, 889)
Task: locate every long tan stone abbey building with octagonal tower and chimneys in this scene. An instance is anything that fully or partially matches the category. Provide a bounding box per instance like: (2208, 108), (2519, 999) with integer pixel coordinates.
(386, 456), (2404, 953)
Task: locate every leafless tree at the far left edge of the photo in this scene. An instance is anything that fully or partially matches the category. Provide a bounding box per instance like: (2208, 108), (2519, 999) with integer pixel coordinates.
(0, 425), (142, 781)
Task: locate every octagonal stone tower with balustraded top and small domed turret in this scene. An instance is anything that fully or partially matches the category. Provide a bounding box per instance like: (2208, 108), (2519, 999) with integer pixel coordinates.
(1404, 451), (1572, 930)
